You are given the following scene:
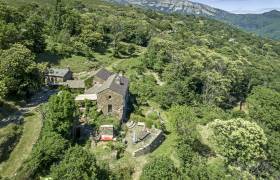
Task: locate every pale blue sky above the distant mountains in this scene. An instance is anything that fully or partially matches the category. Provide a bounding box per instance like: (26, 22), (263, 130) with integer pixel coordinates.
(191, 0), (280, 14)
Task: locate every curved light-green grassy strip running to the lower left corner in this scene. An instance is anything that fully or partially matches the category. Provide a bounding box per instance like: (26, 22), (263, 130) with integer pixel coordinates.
(0, 111), (42, 177)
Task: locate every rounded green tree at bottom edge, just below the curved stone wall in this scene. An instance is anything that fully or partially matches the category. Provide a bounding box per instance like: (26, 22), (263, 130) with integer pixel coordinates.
(140, 156), (178, 180)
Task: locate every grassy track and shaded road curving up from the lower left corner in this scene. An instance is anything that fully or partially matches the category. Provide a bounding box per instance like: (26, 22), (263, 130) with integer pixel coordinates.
(0, 90), (57, 177)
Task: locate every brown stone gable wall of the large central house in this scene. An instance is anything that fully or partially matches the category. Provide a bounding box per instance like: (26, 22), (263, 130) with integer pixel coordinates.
(97, 89), (127, 119)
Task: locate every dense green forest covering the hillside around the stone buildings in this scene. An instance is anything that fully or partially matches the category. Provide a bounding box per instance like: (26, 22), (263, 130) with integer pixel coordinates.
(0, 0), (280, 179)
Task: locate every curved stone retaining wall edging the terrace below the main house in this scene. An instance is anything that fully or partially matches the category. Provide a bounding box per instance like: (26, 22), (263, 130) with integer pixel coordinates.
(132, 130), (164, 157)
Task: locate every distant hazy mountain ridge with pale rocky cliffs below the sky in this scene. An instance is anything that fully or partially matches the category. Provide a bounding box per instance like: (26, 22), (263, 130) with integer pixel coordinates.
(107, 0), (280, 40)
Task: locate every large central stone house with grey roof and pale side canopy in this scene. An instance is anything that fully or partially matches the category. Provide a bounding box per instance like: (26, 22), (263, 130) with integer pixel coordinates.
(76, 69), (129, 120)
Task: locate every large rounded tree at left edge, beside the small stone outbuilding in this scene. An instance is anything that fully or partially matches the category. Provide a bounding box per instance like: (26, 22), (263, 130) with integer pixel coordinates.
(0, 44), (42, 96)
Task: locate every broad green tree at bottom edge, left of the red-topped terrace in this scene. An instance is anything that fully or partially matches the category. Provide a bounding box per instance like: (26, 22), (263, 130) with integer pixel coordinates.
(51, 145), (104, 180)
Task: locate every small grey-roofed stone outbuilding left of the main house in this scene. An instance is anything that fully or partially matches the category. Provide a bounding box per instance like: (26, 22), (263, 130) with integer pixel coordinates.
(45, 68), (73, 85)
